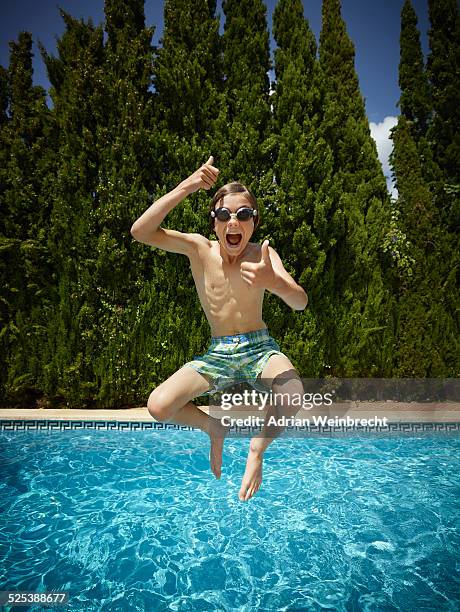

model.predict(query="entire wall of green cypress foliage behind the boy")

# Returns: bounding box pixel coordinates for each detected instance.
[0,0,460,407]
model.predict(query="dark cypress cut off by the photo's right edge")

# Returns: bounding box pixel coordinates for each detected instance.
[424,0,460,376]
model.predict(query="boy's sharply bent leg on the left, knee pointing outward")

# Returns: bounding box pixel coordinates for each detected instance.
[147,366,227,478]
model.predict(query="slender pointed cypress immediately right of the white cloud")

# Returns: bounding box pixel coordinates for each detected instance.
[386,2,458,377]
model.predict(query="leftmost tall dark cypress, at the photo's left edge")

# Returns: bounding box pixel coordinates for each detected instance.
[0,32,51,403]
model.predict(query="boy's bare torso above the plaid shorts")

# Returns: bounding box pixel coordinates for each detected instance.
[190,240,266,336]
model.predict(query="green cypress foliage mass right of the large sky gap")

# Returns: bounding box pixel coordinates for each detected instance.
[386,0,459,376]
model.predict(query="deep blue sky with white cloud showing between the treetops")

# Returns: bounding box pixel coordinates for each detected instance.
[0,0,429,189]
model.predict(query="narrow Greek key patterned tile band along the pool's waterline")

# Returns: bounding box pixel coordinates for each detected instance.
[0,419,460,437]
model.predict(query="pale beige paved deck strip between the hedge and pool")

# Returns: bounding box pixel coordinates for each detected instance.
[0,401,460,423]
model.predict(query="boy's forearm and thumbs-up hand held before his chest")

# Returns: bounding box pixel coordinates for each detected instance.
[240,240,308,310]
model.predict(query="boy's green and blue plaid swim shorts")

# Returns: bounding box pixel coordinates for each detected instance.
[185,329,285,395]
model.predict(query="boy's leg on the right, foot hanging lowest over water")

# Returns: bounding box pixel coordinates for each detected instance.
[239,355,303,501]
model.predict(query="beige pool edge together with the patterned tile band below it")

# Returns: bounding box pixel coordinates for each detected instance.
[0,401,460,437]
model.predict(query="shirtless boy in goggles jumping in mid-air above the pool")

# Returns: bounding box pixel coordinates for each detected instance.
[131,156,308,501]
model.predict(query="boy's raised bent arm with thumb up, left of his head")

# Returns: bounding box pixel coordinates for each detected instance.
[131,156,219,255]
